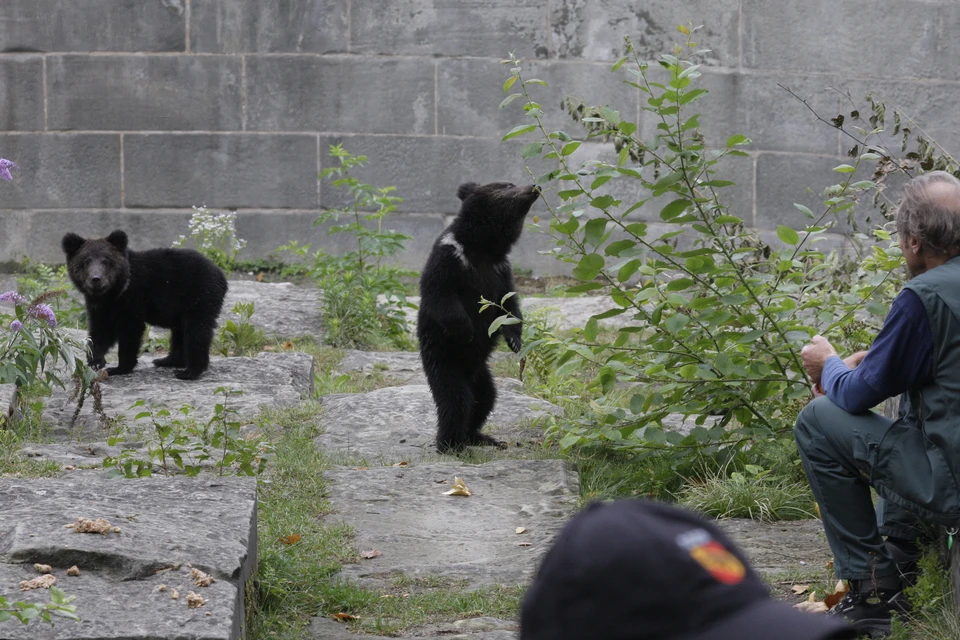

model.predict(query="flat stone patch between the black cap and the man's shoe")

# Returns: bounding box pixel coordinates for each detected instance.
[717,518,833,574]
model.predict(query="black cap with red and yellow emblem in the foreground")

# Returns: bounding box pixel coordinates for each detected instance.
[520,500,856,640]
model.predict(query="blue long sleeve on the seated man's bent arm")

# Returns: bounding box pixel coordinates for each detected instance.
[820,289,934,413]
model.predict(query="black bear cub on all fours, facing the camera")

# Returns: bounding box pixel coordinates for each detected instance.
[61,230,227,380]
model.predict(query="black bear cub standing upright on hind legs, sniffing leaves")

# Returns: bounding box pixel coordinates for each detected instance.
[417,182,540,453]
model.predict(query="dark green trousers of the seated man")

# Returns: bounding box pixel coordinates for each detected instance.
[794,396,922,580]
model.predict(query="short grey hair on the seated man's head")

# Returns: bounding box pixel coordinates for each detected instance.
[897,171,960,257]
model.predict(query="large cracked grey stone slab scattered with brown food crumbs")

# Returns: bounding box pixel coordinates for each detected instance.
[0,473,257,640]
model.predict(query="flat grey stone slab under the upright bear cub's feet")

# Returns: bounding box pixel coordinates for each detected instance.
[315,385,561,464]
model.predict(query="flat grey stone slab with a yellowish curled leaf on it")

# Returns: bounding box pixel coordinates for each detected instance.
[325,460,579,588]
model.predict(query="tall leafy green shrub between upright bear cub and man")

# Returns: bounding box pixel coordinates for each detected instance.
[501,27,901,456]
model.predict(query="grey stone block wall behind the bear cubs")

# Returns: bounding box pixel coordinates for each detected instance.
[0,0,960,273]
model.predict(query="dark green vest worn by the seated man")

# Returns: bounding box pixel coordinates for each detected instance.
[872,257,960,524]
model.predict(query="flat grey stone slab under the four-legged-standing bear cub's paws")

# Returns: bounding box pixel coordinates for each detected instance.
[44,352,313,442]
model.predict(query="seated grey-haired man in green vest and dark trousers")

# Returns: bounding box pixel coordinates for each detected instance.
[794,171,960,637]
